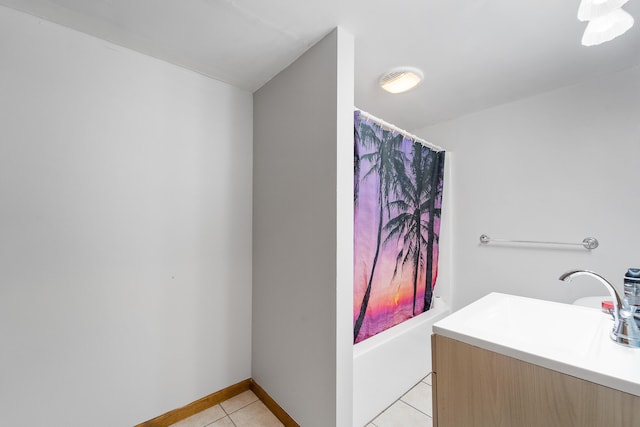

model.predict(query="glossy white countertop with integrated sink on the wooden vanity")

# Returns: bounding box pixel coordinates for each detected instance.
[433,293,640,396]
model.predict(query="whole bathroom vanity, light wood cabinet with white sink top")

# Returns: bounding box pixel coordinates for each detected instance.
[432,293,640,427]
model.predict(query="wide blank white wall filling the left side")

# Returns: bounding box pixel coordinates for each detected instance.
[0,7,252,427]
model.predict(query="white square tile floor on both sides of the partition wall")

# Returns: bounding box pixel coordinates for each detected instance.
[172,374,433,427]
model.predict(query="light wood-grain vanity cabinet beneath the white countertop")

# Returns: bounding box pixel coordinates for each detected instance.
[431,334,640,427]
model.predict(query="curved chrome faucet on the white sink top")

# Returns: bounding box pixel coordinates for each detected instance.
[560,270,640,347]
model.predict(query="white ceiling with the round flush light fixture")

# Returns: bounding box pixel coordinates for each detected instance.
[0,0,640,130]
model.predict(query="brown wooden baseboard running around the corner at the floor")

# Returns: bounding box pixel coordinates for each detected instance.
[135,378,300,427]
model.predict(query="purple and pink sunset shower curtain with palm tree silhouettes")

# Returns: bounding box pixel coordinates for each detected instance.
[353,111,445,343]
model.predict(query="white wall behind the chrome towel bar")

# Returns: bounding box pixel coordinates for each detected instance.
[416,67,640,308]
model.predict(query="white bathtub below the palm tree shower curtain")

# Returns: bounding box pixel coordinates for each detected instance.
[353,300,451,427]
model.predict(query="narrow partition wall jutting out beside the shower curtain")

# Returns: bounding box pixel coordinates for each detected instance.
[252,29,354,427]
